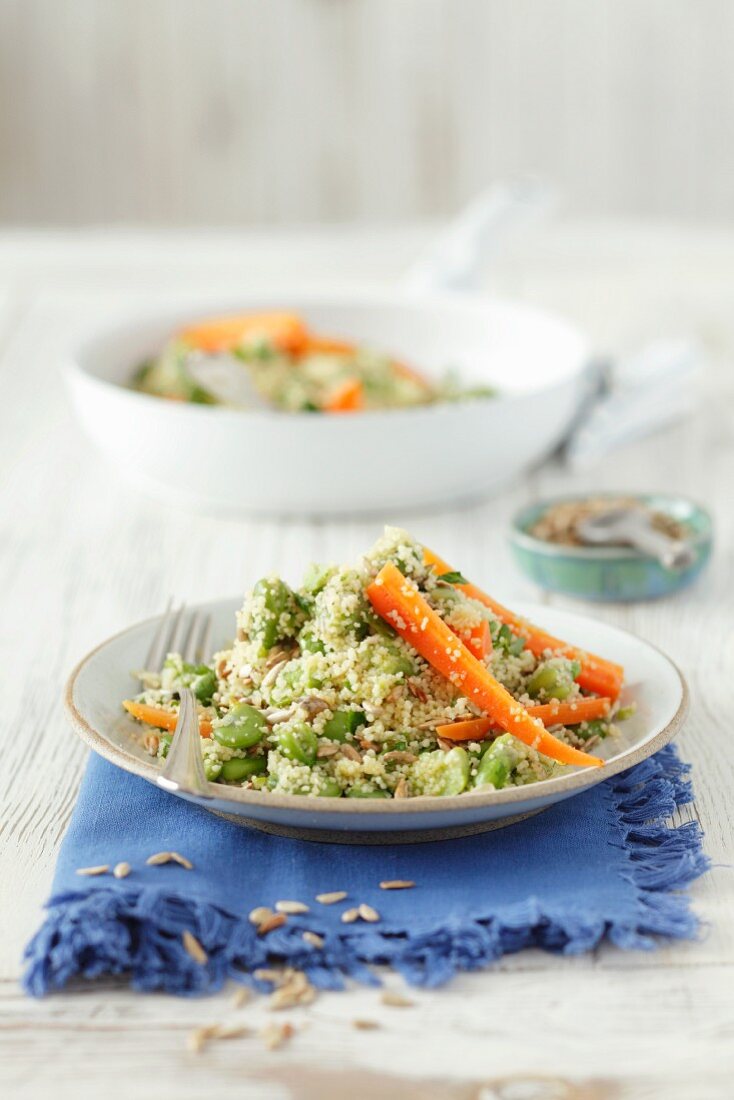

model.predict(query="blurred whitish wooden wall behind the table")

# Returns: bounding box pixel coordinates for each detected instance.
[0,0,734,224]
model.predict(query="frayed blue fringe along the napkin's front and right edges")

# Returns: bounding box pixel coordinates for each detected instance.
[23,747,709,997]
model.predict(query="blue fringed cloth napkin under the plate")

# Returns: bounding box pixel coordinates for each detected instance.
[25,747,708,996]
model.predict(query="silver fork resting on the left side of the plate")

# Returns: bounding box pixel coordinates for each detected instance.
[145,600,211,799]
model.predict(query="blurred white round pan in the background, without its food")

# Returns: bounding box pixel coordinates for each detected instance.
[67,293,587,516]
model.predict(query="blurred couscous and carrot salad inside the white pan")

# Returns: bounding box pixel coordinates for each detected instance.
[133,314,493,414]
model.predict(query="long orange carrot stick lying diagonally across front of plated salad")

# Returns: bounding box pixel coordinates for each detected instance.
[366,562,603,767]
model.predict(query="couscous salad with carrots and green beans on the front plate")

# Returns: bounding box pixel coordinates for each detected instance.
[123,528,628,799]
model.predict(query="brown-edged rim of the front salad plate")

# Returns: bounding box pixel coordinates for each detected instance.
[63,596,690,823]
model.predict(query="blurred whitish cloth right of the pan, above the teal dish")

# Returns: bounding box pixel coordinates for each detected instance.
[563,339,703,469]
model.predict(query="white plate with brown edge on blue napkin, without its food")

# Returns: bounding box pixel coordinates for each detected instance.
[65,600,687,844]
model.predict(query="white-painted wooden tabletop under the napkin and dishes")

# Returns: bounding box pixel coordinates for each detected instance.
[0,224,734,1100]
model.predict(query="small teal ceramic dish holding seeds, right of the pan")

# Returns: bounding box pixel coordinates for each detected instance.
[511,493,712,602]
